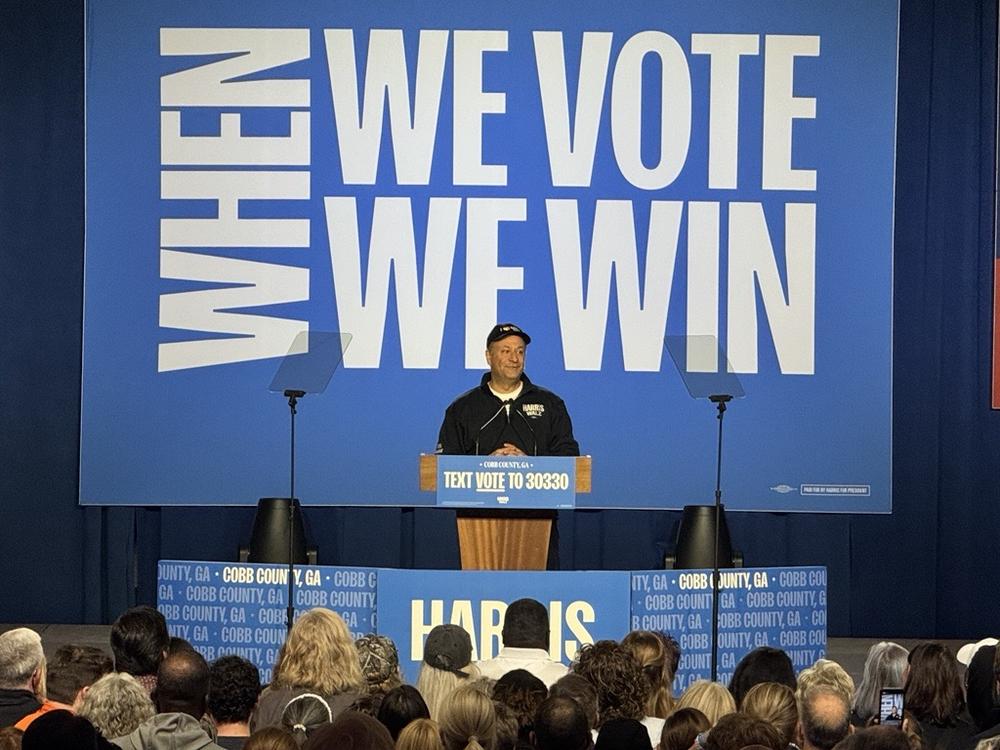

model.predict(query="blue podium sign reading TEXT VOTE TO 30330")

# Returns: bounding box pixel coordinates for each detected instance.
[437,456,576,508]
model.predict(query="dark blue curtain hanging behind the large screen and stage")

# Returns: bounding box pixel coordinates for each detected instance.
[0,0,1000,637]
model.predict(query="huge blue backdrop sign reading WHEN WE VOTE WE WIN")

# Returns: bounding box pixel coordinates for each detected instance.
[80,0,898,512]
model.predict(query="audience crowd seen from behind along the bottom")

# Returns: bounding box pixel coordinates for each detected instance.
[0,599,1000,750]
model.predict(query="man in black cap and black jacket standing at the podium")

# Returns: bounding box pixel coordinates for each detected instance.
[437,323,580,456]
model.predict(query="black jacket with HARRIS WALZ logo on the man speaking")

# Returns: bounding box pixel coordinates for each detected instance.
[437,373,580,456]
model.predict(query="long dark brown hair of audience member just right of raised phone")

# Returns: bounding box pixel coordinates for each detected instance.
[903,643,965,725]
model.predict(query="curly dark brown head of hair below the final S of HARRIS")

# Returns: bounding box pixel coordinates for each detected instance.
[573,641,649,725]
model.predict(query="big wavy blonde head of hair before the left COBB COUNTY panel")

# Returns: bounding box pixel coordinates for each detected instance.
[271,607,364,695]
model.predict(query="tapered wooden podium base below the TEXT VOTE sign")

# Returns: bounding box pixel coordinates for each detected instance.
[457,511,554,570]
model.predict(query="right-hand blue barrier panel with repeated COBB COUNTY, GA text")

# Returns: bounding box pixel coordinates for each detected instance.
[630,567,826,693]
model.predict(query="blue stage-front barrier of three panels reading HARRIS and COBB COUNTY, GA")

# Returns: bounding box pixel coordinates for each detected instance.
[158,560,826,692]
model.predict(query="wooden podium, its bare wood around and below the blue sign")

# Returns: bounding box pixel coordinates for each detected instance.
[420,453,591,570]
